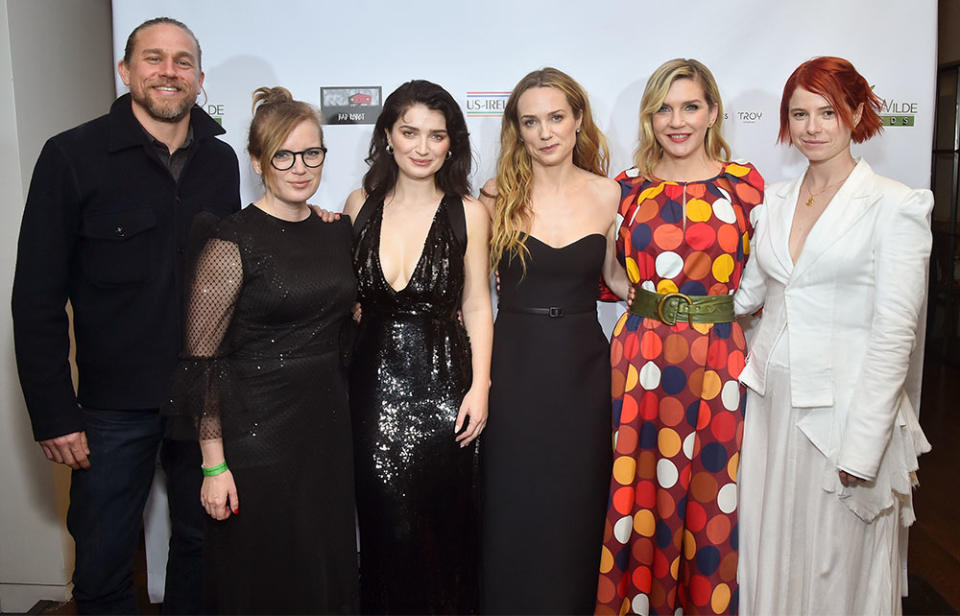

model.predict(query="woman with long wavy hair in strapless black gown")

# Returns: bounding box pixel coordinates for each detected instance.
[481,68,627,614]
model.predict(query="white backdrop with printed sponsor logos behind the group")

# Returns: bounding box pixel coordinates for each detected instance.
[113,0,937,598]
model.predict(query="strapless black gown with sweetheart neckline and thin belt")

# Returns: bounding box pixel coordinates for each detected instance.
[481,234,611,614]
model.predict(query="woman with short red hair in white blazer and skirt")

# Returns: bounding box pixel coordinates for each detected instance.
[735,57,933,614]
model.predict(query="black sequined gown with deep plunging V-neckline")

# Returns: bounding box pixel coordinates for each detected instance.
[350,197,478,614]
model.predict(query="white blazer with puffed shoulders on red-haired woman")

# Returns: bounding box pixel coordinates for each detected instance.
[734,160,933,520]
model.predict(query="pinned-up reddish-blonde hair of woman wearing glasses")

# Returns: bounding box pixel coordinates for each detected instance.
[247,86,323,188]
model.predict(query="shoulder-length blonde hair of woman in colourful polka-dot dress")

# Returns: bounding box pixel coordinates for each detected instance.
[633,58,730,178]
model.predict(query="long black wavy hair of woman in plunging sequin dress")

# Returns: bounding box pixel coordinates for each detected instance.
[363,79,472,201]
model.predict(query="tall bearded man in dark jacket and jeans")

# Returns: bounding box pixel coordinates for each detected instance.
[13,17,240,614]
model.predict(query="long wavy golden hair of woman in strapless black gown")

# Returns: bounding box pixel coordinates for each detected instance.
[490,67,610,269]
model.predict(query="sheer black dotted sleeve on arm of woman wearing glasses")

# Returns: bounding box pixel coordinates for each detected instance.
[163,238,243,440]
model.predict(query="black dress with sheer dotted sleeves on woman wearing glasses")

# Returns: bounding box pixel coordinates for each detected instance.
[164,206,358,614]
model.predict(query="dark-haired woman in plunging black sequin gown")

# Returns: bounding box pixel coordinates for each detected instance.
[345,81,493,614]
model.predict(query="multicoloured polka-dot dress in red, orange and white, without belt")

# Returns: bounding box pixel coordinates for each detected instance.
[597,163,763,614]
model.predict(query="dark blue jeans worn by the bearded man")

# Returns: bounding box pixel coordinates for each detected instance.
[67,409,204,614]
